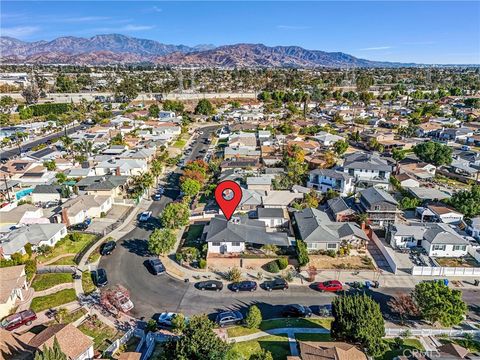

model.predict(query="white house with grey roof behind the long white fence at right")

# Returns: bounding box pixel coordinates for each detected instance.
[389,223,469,257]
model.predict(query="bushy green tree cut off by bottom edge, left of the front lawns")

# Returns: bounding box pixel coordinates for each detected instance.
[164,315,231,360]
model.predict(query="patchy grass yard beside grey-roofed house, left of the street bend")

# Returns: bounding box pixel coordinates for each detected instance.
[37,233,96,265]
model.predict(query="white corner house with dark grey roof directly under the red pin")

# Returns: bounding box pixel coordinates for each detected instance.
[202,216,292,254]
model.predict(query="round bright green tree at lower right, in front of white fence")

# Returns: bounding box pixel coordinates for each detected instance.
[412,280,467,327]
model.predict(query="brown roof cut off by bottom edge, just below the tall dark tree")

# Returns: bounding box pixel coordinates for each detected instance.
[288,341,367,360]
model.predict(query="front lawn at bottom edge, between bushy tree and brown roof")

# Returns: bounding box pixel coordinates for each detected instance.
[233,334,290,360]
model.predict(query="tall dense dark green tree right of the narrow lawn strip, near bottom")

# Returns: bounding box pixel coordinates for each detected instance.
[330,294,385,356]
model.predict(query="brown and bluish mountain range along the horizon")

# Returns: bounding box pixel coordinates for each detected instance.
[0,34,415,68]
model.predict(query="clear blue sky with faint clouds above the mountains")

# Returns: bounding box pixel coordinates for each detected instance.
[1,1,480,64]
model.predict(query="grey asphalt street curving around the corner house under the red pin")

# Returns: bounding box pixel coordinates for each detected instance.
[99,128,480,319]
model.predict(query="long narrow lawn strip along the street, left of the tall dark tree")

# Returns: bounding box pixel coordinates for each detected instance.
[227,318,332,337]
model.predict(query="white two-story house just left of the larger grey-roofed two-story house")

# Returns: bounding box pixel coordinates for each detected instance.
[307,169,355,196]
